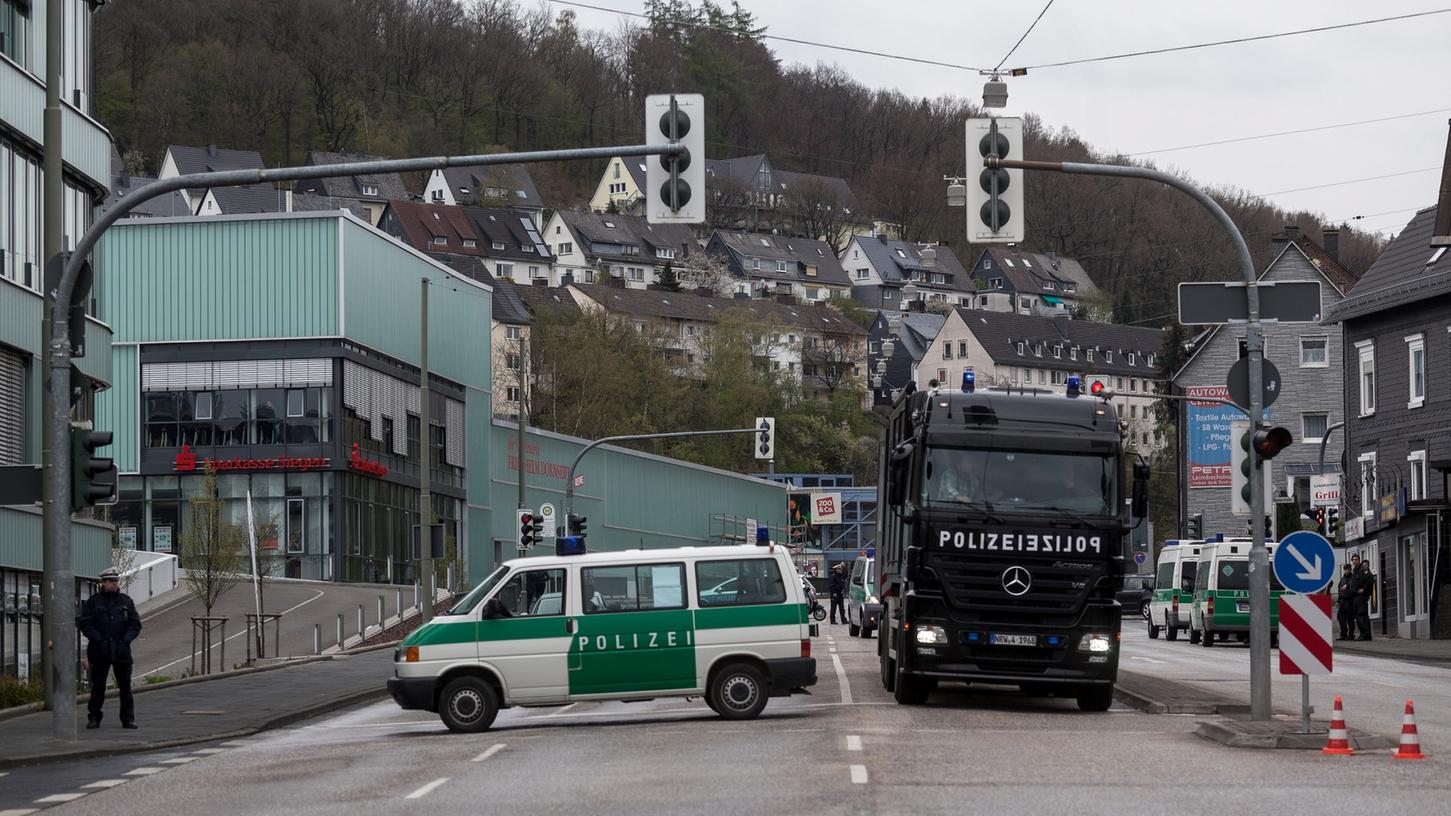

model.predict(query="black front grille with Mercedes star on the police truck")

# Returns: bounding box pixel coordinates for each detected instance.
[927,552,1107,623]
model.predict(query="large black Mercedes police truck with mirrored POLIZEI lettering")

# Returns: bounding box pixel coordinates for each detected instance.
[876,372,1148,711]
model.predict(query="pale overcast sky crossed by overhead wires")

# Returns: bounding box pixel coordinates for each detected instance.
[556,0,1451,238]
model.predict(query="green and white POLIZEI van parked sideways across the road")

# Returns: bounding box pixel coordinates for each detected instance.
[387,546,815,732]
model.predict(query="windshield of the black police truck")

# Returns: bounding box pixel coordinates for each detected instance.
[921,447,1119,517]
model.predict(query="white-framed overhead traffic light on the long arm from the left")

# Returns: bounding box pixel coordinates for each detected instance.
[644,93,705,224]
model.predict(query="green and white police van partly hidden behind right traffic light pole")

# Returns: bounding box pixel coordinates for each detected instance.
[1188,539,1284,646]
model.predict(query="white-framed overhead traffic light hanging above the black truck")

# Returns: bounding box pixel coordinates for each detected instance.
[966,116,1024,244]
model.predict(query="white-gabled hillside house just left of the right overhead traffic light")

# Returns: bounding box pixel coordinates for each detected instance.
[842,235,977,311]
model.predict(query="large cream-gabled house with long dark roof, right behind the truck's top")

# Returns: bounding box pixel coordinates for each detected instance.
[922,306,1171,452]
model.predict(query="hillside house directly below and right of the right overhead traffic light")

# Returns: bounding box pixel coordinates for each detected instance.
[969,247,1097,317]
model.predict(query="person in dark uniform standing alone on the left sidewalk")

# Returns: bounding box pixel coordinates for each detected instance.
[78,568,141,729]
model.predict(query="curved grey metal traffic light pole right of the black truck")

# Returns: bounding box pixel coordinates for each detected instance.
[985,157,1273,720]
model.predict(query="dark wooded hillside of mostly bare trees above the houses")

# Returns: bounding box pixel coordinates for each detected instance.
[94,0,1380,325]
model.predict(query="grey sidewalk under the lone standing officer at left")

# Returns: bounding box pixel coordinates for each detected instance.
[0,649,393,768]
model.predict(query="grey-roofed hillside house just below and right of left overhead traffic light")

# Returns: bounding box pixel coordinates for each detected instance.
[705,229,852,301]
